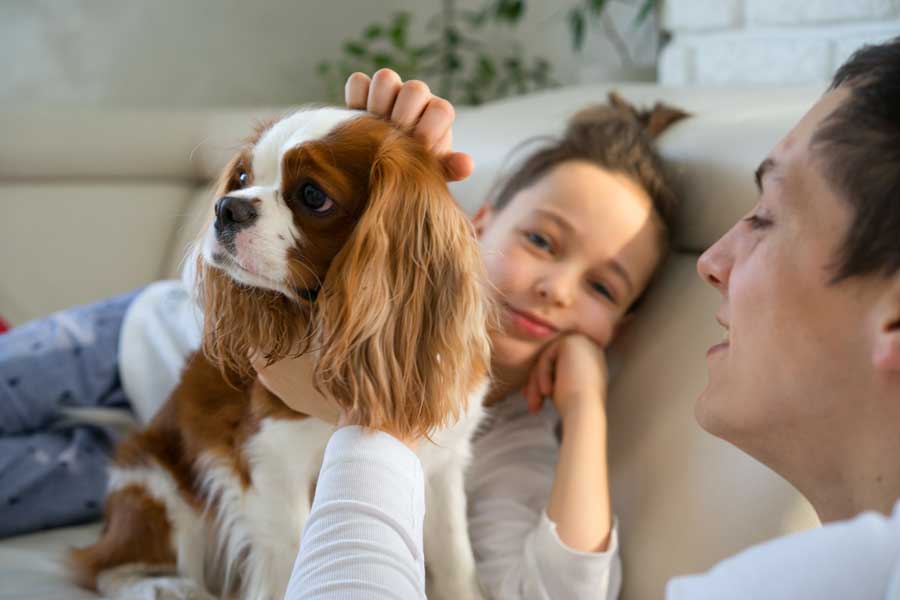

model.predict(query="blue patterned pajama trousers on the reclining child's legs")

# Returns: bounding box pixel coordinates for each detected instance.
[0,291,139,537]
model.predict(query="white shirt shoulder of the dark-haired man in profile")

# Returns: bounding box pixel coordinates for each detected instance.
[666,502,900,600]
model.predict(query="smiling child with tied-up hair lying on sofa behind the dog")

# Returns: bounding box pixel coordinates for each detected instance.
[0,71,683,598]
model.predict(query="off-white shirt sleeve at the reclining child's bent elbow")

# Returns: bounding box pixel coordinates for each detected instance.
[466,396,622,600]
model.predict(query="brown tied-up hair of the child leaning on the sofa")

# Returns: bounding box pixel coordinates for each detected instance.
[493,92,689,248]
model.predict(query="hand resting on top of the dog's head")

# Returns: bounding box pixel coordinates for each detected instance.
[344,69,472,181]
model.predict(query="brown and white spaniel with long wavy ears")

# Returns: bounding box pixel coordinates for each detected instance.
[69,107,493,600]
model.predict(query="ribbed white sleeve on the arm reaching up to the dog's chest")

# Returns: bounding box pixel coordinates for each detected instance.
[285,427,425,600]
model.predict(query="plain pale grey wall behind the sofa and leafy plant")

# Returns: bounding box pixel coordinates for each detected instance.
[0,0,656,107]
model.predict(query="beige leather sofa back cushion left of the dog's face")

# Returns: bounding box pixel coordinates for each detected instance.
[0,181,191,325]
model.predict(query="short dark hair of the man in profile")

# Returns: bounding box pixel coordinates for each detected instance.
[812,37,900,282]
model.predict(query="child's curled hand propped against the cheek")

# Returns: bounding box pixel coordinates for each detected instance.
[523,334,608,421]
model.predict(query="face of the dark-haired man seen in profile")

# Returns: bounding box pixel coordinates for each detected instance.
[696,89,882,464]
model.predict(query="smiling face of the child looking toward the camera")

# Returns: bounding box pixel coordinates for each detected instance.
[473,161,661,366]
